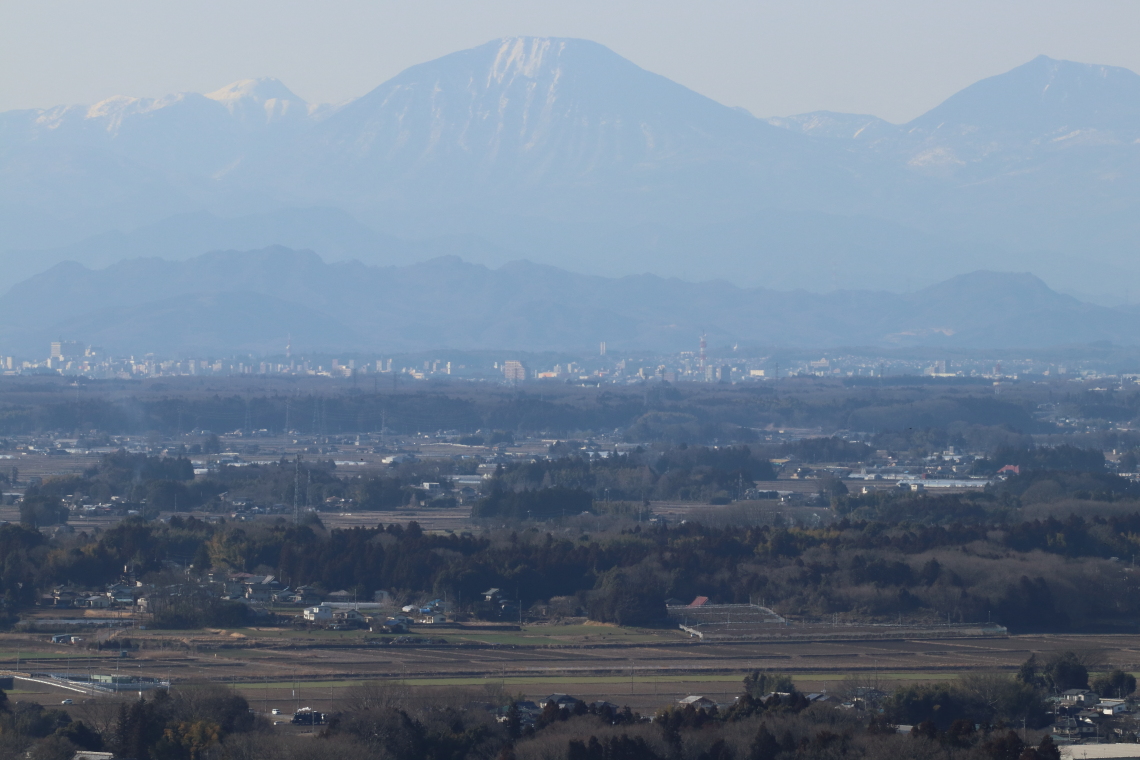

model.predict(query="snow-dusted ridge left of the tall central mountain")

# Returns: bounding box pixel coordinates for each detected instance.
[0,80,328,247]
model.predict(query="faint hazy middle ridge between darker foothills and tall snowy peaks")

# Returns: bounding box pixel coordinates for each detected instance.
[0,207,994,293]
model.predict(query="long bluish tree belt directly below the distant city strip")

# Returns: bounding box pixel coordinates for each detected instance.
[0,378,1067,448]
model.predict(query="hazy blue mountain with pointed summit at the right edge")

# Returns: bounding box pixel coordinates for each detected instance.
[768,56,1140,255]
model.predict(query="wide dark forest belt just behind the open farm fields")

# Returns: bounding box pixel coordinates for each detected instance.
[0,492,1140,630]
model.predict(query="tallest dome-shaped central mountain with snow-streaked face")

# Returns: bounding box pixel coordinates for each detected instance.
[247,38,857,224]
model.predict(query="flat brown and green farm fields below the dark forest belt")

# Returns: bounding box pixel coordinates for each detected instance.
[0,624,1140,712]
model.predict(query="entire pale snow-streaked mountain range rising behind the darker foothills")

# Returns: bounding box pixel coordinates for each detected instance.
[0,38,1140,296]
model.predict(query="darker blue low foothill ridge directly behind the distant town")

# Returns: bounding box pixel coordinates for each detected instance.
[0,247,1140,357]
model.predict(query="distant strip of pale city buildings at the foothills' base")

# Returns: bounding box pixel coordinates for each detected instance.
[0,337,1140,384]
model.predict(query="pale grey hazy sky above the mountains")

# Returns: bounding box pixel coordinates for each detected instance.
[0,0,1140,122]
